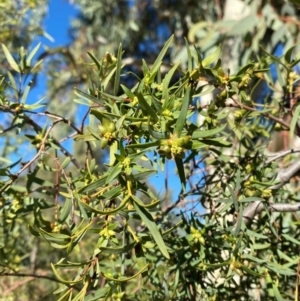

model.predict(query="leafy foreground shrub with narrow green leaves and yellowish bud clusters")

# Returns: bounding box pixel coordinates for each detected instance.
[0,25,300,301]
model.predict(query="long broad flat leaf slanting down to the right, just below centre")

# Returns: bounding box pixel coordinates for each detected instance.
[133,199,170,259]
